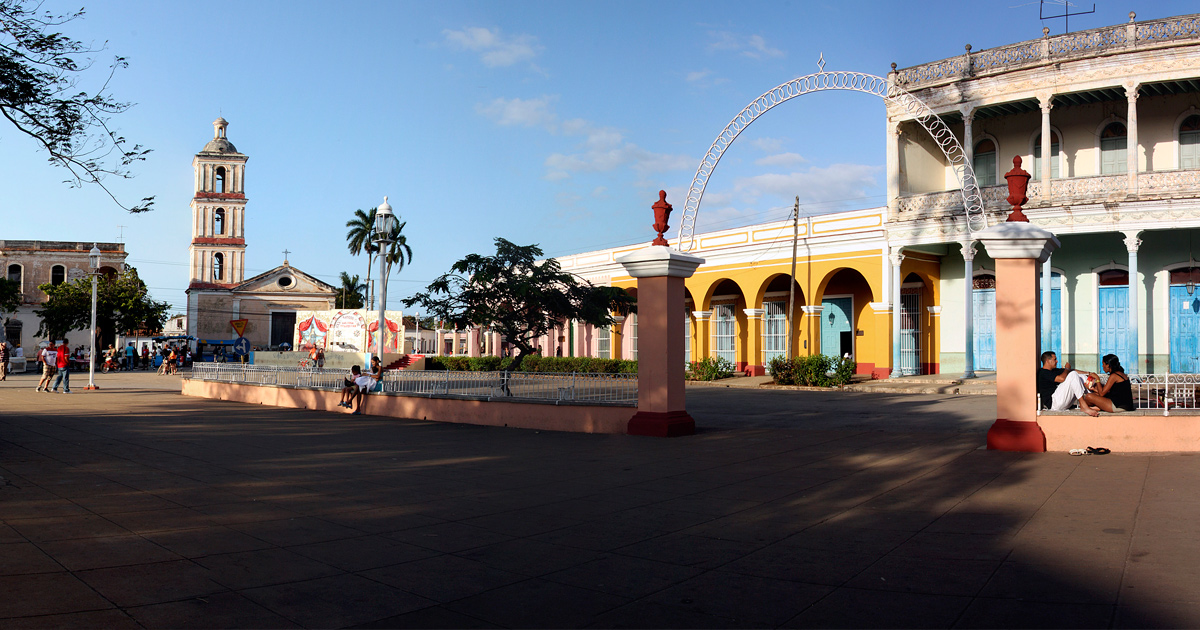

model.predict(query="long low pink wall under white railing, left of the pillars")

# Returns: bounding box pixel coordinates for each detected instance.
[182,379,637,433]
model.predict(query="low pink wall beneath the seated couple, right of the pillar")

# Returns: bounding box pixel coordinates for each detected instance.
[1038,414,1200,452]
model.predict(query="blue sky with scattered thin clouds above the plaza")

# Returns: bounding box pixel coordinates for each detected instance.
[0,0,1195,313]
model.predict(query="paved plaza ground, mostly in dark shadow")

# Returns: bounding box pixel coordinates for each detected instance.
[0,373,1200,628]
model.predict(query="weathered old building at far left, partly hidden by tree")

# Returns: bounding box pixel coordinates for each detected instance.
[0,241,126,348]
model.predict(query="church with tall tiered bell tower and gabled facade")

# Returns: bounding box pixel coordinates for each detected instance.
[187,118,336,348]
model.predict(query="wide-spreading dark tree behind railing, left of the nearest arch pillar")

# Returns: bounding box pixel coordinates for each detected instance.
[404,239,634,370]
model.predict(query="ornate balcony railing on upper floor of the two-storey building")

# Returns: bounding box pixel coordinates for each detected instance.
[893,170,1200,221]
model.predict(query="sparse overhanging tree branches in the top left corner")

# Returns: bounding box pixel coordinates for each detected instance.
[0,0,154,212]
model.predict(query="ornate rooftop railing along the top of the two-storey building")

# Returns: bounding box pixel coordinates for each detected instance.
[892,13,1200,91]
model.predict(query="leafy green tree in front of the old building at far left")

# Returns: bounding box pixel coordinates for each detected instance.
[34,266,170,338]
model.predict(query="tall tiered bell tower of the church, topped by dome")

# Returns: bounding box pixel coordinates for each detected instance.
[188,118,247,288]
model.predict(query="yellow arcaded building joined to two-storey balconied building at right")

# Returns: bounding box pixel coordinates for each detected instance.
[530,13,1200,376]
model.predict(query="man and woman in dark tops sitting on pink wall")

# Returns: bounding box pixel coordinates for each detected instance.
[1038,352,1136,418]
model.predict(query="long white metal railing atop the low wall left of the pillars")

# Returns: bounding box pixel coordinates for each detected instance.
[192,362,637,406]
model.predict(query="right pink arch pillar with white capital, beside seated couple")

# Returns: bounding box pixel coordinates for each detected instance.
[976,221,1060,452]
